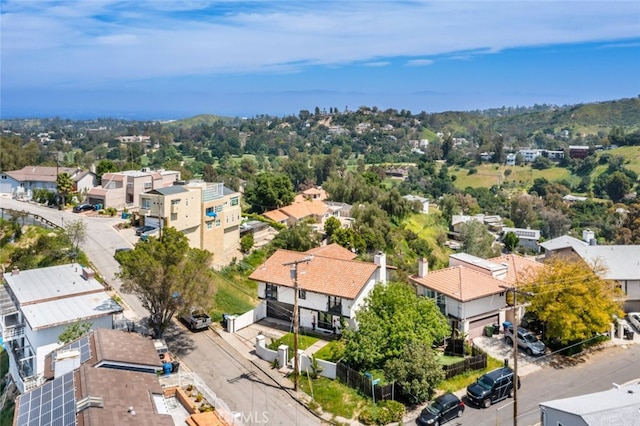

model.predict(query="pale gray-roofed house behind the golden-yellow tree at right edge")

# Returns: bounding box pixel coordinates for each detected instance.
[540,230,640,312]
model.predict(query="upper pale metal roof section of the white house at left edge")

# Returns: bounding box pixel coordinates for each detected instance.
[3,263,104,306]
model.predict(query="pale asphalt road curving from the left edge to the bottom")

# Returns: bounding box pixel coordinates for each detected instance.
[0,198,321,425]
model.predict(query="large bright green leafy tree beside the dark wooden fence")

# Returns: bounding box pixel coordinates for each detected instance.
[344,282,450,369]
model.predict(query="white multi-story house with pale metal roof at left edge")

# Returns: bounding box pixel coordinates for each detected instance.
[0,263,122,393]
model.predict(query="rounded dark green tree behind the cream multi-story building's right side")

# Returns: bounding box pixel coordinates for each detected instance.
[245,172,295,212]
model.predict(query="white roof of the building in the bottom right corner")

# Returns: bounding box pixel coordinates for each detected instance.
[540,384,640,426]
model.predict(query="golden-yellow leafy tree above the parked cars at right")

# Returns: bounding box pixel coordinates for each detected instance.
[522,258,623,344]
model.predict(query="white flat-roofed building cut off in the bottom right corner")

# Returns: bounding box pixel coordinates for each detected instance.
[540,381,640,426]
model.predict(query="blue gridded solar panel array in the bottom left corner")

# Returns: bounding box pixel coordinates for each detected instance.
[16,371,76,426]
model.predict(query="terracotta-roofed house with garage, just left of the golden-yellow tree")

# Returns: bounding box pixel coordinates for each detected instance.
[409,253,543,339]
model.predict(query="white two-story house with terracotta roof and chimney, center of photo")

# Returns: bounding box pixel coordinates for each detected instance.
[249,244,388,332]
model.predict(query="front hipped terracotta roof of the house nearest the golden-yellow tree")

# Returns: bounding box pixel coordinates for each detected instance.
[409,265,507,302]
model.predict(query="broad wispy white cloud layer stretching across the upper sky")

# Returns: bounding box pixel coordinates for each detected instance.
[0,0,640,86]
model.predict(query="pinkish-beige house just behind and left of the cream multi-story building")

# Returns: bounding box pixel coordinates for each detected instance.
[87,169,180,209]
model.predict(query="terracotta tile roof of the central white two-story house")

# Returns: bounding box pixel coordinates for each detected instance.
[249,249,378,299]
